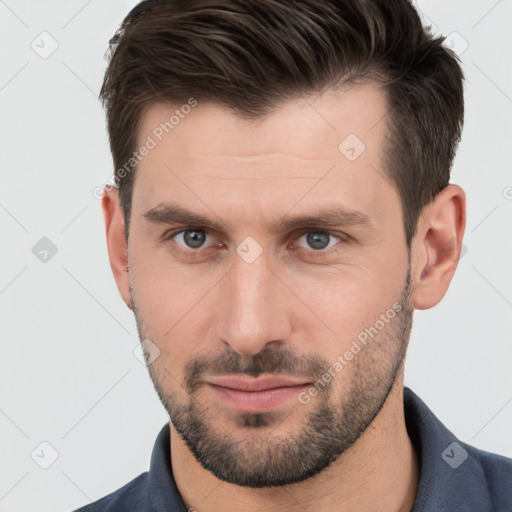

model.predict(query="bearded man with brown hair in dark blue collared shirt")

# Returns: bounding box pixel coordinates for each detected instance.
[74,0,512,512]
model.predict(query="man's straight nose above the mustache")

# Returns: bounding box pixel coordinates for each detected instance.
[216,249,291,354]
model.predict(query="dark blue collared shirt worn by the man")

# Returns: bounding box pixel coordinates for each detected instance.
[71,388,512,512]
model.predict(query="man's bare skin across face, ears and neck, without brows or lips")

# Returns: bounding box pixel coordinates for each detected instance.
[103,84,465,512]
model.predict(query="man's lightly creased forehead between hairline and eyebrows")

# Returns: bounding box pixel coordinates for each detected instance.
[133,84,396,224]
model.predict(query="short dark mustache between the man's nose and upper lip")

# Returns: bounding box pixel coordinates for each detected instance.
[184,347,329,393]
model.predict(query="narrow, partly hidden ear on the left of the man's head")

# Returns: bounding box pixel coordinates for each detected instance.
[101,187,132,309]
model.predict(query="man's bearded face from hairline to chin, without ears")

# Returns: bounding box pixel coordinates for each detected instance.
[128,85,412,487]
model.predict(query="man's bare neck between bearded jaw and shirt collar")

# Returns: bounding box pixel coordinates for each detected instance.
[170,374,419,512]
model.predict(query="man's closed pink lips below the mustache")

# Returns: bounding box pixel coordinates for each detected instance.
[206,376,311,413]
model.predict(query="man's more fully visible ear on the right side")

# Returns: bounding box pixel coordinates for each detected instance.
[411,185,466,309]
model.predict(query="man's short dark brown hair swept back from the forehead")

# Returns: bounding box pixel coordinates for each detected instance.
[100,0,464,244]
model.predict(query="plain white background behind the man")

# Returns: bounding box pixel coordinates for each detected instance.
[0,0,512,512]
